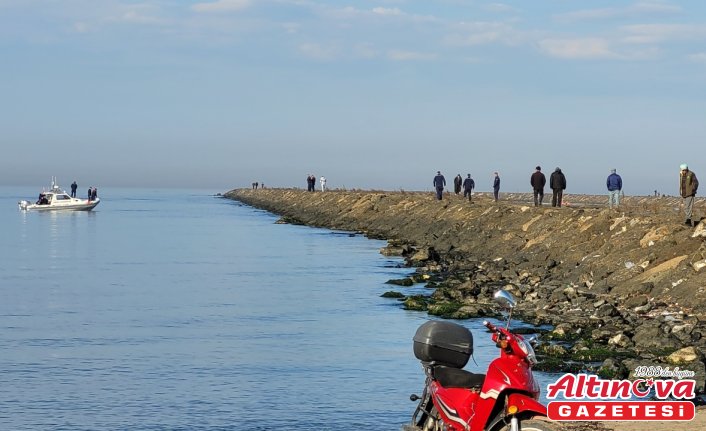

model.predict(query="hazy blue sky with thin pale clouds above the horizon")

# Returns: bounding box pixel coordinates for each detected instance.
[0,0,706,195]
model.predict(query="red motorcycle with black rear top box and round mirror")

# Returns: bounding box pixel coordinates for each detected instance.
[404,290,556,431]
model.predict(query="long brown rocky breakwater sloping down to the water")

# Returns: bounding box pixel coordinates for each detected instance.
[225,189,706,392]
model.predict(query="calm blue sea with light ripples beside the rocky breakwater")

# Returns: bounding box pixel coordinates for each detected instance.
[0,187,556,431]
